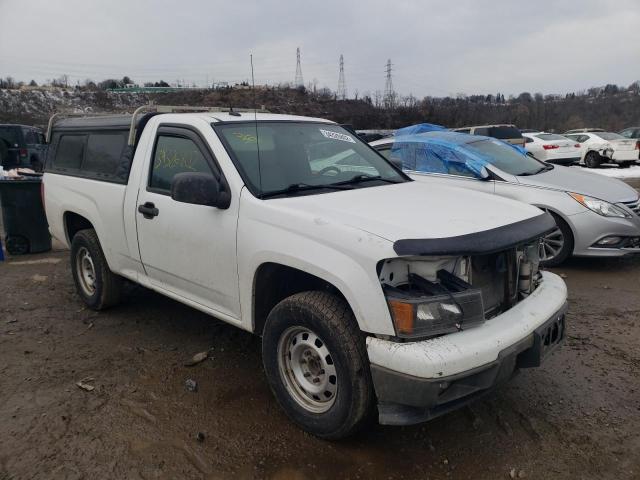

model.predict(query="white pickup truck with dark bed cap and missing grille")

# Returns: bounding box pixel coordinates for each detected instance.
[44,107,567,439]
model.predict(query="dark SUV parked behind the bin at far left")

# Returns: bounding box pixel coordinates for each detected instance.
[0,124,47,172]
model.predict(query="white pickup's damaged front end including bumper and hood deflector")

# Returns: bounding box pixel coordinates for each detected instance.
[367,213,567,425]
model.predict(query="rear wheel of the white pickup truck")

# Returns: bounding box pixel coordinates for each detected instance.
[71,229,123,310]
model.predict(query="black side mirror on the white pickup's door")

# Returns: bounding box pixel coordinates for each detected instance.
[171,172,231,209]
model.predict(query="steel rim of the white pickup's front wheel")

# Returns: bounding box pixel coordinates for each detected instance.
[278,327,338,413]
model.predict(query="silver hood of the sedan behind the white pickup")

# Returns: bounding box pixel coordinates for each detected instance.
[517,165,638,203]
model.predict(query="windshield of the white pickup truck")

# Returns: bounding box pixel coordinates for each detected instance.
[213,121,406,198]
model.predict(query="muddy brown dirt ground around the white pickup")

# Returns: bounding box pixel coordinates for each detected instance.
[0,182,640,480]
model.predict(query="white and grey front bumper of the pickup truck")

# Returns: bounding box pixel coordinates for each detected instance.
[367,272,567,425]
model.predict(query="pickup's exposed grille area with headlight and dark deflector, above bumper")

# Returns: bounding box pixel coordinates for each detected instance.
[378,213,555,341]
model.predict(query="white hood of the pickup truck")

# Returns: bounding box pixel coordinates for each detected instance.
[268,181,542,242]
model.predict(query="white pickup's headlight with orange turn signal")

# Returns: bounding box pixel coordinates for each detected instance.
[387,289,484,338]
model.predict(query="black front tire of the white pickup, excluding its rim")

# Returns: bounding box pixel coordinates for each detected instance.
[262,291,375,440]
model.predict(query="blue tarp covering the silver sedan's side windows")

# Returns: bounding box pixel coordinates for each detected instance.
[391,127,495,178]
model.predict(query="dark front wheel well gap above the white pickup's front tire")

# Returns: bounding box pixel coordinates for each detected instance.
[253,263,346,335]
